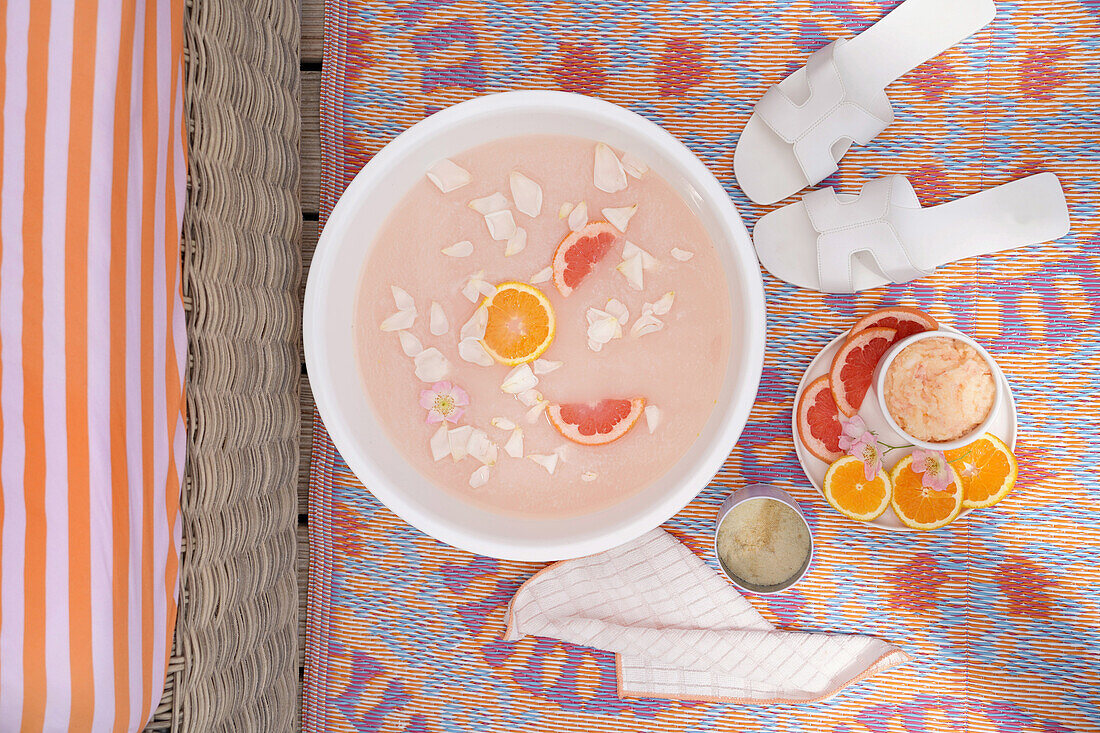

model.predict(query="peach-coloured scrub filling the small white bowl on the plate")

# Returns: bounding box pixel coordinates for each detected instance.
[883,337,997,442]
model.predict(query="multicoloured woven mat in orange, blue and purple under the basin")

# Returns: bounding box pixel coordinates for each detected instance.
[304,0,1100,733]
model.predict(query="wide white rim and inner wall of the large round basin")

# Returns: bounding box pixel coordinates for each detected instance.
[303,91,766,560]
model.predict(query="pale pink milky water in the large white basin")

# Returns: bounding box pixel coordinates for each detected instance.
[354,135,730,516]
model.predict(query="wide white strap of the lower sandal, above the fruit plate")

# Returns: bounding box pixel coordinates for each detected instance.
[802,176,931,293]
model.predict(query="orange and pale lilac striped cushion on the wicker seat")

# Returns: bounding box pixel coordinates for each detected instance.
[0,0,186,731]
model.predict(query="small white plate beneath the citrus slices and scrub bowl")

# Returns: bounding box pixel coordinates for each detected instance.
[791,326,1016,532]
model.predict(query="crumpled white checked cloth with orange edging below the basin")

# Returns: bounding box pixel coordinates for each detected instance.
[504,529,910,703]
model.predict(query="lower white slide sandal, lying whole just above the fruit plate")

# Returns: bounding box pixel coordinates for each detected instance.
[752,173,1069,293]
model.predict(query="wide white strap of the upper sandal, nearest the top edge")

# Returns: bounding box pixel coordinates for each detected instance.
[755,39,893,184]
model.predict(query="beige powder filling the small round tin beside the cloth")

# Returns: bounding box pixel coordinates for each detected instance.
[718,497,811,587]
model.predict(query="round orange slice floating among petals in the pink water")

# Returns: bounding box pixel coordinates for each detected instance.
[481,283,556,367]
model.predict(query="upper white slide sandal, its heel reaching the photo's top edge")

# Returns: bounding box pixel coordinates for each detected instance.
[734,0,996,205]
